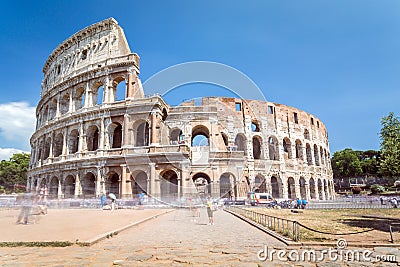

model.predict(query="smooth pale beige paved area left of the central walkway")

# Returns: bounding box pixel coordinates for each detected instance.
[0,209,168,243]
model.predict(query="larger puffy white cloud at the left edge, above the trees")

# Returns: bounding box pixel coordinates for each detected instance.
[0,102,36,149]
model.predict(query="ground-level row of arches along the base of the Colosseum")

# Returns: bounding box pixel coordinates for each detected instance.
[28,169,334,200]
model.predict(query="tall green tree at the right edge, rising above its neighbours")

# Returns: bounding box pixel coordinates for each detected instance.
[379,112,400,178]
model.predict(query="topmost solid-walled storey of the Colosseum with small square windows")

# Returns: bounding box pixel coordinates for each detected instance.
[41,18,139,96]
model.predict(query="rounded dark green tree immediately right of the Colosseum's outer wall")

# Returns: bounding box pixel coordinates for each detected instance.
[331,148,363,178]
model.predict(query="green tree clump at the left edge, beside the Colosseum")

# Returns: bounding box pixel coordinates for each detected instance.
[0,153,30,193]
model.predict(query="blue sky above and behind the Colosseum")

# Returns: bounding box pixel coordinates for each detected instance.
[0,0,400,159]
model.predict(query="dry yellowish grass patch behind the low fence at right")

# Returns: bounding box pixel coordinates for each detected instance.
[244,208,400,243]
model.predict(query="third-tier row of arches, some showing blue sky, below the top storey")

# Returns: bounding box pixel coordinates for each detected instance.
[37,76,126,126]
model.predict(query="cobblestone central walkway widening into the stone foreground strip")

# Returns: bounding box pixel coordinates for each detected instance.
[0,209,400,266]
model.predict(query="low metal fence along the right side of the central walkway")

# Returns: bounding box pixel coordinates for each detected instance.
[226,206,300,241]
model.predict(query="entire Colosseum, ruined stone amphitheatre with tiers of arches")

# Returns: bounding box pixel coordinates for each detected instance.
[27,18,334,201]
